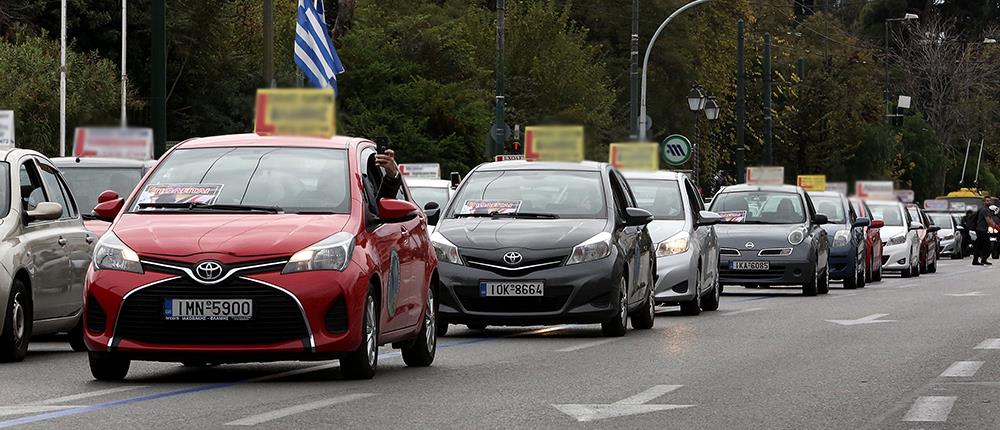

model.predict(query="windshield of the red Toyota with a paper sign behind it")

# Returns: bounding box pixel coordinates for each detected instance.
[130,147,351,213]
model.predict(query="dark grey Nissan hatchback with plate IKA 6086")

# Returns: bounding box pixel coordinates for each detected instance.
[710,184,830,296]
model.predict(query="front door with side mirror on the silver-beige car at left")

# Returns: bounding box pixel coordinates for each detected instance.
[18,156,72,320]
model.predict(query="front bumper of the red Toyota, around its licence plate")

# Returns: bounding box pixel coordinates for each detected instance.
[84,262,368,362]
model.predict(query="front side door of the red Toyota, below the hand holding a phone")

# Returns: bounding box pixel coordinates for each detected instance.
[358,146,406,333]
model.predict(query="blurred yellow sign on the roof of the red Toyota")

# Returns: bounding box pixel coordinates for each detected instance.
[254,88,337,137]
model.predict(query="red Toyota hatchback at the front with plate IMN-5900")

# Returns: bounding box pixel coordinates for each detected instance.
[84,134,438,380]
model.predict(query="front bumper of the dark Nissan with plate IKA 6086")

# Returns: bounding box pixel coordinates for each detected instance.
[719,256,816,285]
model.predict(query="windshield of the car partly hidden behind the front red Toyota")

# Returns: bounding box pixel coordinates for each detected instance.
[59,166,143,207]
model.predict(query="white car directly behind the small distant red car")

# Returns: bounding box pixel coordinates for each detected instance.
[867,200,924,278]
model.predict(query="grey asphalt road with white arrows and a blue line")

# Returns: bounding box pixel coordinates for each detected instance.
[0,259,1000,429]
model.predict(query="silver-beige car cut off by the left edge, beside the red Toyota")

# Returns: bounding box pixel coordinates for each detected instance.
[0,149,96,361]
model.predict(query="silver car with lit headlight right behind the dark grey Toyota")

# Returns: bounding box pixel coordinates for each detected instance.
[624,171,721,315]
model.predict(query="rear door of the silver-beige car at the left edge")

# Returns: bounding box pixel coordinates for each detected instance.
[35,159,94,315]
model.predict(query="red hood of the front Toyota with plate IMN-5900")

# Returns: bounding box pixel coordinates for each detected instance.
[114,214,350,257]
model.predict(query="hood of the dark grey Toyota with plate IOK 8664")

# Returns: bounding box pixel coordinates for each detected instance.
[436,218,608,250]
